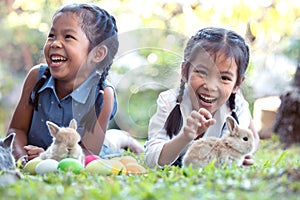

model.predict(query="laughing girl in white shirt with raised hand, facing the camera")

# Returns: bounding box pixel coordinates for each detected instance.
[145,28,259,167]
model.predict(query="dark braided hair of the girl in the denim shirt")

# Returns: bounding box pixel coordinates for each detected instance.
[30,4,119,131]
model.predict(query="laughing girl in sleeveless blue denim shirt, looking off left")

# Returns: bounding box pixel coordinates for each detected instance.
[8,4,142,160]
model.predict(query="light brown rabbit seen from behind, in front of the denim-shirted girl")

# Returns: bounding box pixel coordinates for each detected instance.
[39,119,84,164]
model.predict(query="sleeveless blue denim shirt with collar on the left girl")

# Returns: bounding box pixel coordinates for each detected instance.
[28,65,117,149]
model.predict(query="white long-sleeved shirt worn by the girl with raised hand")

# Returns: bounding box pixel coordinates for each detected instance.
[145,89,251,167]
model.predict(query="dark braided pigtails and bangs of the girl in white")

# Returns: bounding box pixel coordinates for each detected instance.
[165,27,249,138]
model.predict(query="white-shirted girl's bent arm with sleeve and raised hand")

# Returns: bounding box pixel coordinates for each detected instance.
[145,90,215,167]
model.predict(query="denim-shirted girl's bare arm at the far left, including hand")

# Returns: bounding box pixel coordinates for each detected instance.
[7,67,39,160]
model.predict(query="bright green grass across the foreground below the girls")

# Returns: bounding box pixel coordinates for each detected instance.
[0,137,300,200]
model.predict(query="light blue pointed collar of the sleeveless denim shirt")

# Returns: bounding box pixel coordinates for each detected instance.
[38,72,101,104]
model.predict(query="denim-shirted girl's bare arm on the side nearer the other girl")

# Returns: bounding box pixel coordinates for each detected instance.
[82,87,115,155]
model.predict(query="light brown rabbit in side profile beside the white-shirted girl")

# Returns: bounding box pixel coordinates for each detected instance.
[182,116,254,168]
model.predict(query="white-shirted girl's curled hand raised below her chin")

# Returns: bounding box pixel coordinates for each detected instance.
[183,108,216,140]
